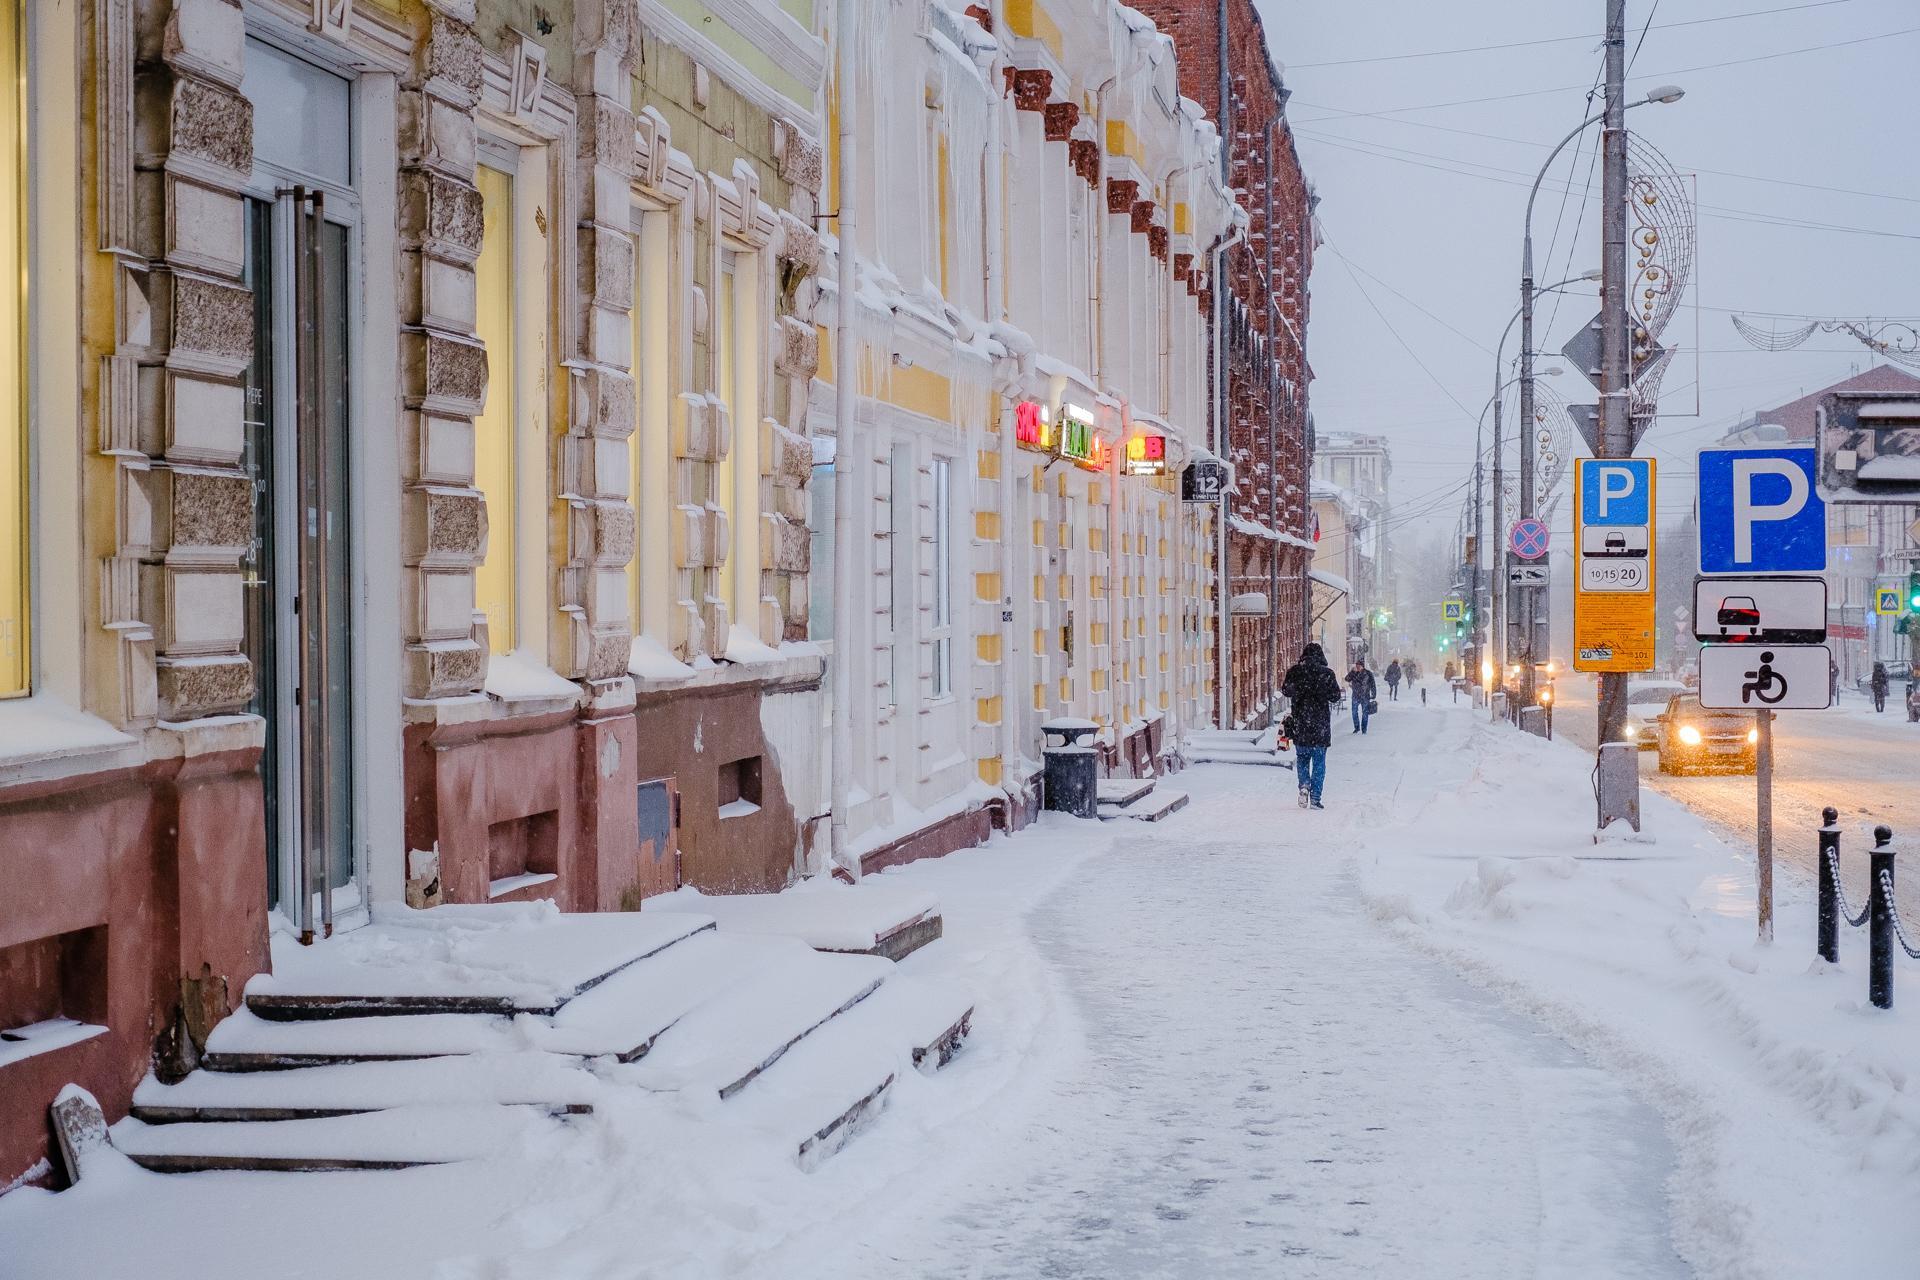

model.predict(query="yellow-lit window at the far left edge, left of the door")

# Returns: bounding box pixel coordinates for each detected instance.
[0,0,29,697]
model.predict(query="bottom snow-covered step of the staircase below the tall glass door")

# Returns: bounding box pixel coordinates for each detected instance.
[111,1103,564,1173]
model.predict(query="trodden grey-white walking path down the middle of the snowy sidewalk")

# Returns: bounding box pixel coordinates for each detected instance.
[787,704,1686,1278]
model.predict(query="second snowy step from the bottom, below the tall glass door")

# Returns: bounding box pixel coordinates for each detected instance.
[132,1052,601,1125]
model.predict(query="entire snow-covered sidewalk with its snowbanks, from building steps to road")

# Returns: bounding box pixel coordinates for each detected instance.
[0,700,1920,1280]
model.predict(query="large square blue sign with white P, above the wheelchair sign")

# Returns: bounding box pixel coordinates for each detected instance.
[1697,447,1826,574]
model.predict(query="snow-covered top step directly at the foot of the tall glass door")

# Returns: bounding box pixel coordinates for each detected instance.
[246,902,712,1019]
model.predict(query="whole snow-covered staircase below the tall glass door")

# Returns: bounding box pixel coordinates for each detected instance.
[111,887,973,1173]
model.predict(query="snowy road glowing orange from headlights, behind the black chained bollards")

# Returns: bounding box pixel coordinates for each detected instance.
[1553,676,1920,912]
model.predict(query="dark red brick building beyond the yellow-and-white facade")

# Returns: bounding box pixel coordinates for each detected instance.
[1135,0,1315,723]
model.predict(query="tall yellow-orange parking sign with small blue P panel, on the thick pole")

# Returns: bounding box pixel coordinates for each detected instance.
[1572,459,1659,672]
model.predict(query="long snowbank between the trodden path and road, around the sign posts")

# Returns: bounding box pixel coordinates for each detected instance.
[1356,716,1920,1280]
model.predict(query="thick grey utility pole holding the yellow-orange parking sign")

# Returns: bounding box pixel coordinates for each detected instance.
[1599,0,1640,756]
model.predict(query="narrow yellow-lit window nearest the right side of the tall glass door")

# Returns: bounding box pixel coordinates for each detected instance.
[474,163,518,652]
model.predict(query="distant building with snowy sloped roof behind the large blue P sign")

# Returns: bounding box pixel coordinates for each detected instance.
[1718,365,1920,685]
